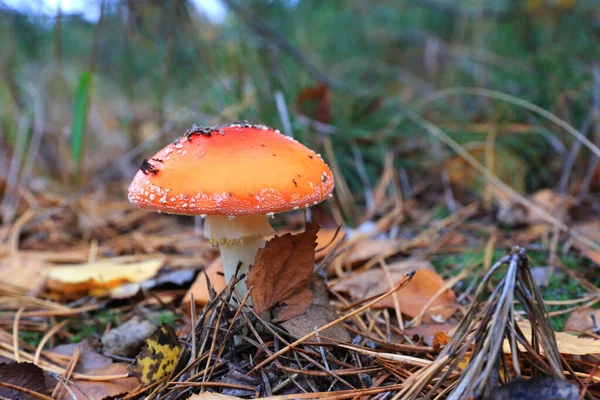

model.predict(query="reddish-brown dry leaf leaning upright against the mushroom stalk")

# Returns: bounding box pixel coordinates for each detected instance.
[246,222,319,322]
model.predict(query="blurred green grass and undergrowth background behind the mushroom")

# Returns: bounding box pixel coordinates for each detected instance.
[0,0,600,223]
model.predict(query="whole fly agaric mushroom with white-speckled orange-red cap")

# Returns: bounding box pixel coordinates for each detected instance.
[128,121,333,295]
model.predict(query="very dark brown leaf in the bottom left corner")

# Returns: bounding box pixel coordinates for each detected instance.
[0,362,47,400]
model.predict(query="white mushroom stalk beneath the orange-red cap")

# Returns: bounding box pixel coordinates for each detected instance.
[204,215,273,304]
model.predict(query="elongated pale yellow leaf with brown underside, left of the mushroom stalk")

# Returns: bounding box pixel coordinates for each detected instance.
[46,257,163,298]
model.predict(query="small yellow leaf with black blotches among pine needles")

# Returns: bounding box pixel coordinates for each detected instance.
[127,324,181,385]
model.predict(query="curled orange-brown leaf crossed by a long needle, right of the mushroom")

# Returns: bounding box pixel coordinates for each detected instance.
[331,261,456,323]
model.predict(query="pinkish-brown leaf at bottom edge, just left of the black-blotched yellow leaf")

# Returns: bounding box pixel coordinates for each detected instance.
[60,363,139,400]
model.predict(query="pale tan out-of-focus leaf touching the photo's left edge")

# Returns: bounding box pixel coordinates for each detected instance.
[0,254,50,296]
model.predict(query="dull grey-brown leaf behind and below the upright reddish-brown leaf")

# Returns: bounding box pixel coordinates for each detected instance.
[273,275,350,342]
